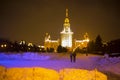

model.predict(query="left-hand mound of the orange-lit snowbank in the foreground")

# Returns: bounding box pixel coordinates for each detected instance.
[0,68,59,80]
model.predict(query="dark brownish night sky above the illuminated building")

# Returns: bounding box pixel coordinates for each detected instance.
[0,0,120,45]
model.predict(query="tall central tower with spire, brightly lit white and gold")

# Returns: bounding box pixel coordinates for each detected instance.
[60,9,73,48]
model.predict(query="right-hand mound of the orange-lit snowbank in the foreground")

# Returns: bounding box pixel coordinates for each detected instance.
[60,68,107,80]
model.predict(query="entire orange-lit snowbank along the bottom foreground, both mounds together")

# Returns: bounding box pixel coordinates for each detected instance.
[0,67,107,80]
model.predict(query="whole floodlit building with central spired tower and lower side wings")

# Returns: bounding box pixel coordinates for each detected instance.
[44,9,89,51]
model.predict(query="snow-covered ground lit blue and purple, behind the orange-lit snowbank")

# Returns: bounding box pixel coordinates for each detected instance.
[0,52,120,80]
